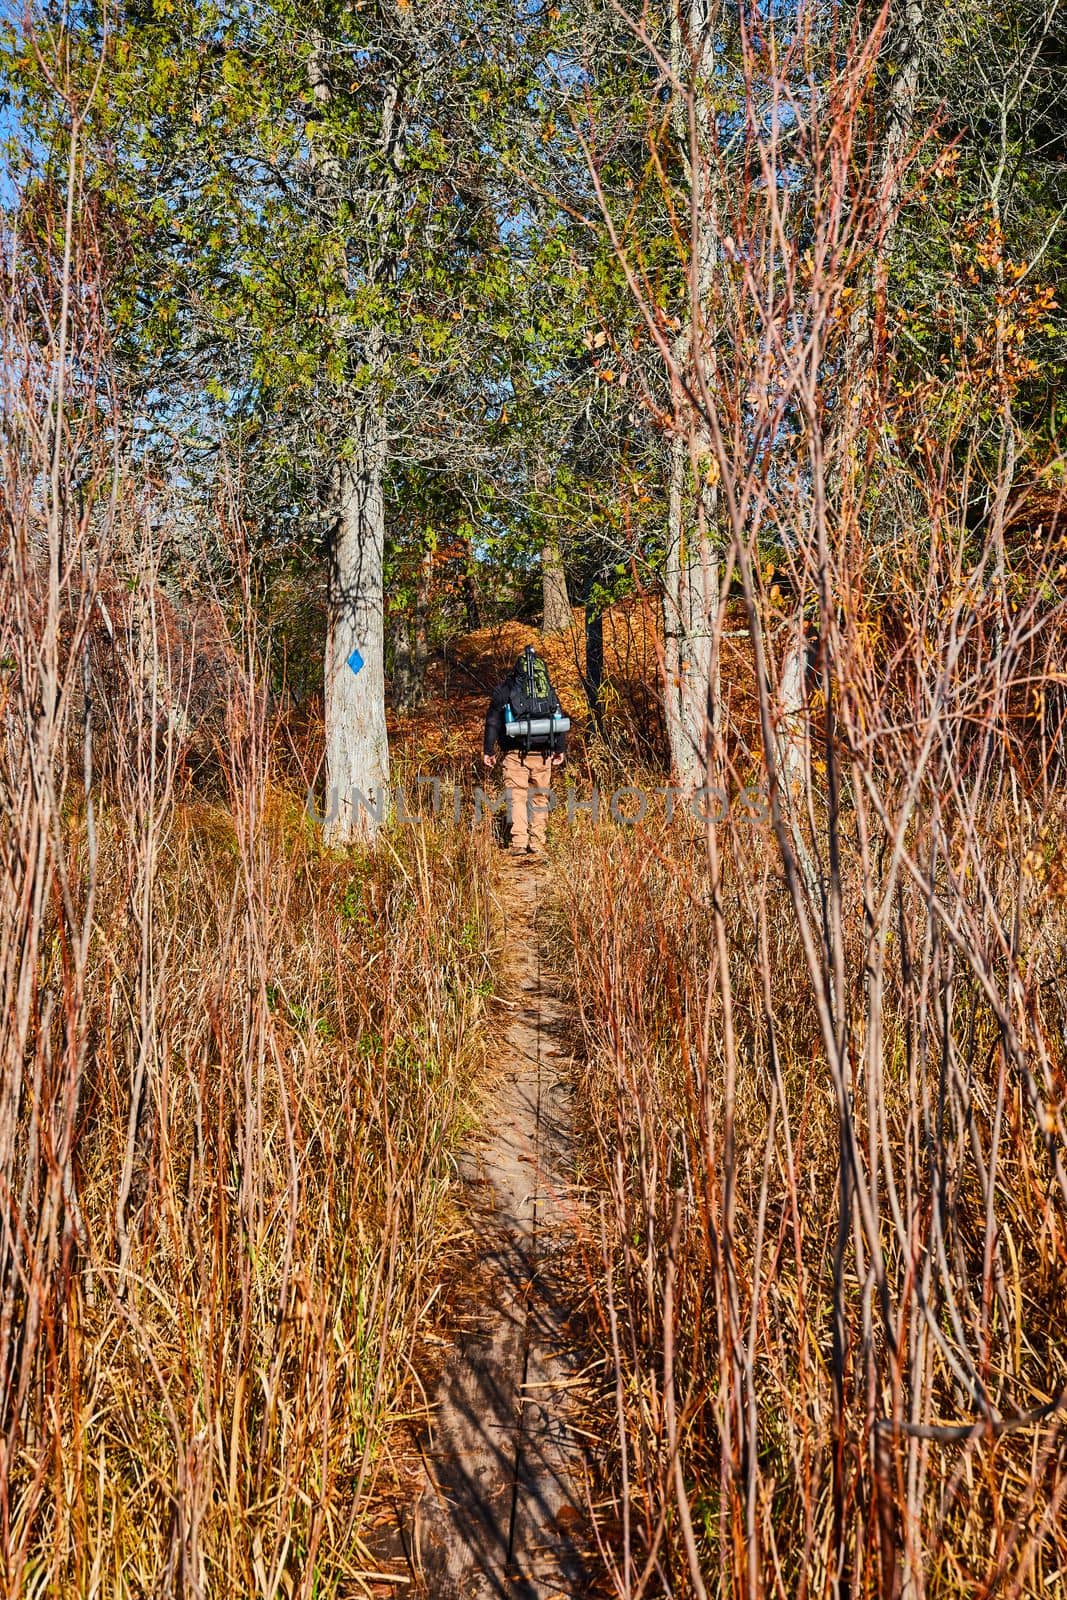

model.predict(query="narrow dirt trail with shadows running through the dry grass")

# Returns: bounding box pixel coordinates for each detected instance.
[379,861,589,1600]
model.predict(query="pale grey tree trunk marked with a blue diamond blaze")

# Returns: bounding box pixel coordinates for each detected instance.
[325,410,389,845]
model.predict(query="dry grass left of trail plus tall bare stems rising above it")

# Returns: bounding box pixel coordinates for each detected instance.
[0,147,494,1597]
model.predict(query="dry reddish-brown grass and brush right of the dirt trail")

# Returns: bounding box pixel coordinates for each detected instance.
[555,790,1067,1597]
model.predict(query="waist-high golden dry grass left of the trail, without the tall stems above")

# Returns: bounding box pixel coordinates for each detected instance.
[5,748,493,1595]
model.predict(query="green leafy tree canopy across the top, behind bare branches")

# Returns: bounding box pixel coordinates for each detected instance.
[3,0,1067,646]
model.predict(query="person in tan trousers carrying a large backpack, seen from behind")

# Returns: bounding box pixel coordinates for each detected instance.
[482,645,571,856]
